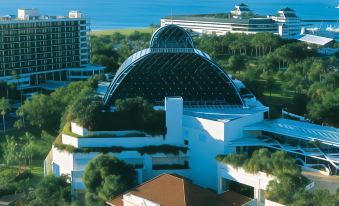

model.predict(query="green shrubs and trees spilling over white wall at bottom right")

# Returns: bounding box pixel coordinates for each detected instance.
[216,149,339,206]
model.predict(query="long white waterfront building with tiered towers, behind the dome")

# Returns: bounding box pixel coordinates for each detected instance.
[160,4,301,38]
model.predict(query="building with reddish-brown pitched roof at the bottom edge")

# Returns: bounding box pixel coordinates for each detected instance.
[107,174,253,206]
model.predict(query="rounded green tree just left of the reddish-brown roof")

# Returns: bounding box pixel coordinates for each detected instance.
[83,154,136,205]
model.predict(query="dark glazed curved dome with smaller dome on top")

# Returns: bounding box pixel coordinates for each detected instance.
[104,25,244,106]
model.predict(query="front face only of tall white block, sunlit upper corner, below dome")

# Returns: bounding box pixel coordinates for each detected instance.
[183,115,224,189]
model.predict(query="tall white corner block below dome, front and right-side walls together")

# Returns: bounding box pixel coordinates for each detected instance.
[183,109,264,190]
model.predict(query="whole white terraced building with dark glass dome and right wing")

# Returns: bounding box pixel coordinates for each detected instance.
[45,25,339,205]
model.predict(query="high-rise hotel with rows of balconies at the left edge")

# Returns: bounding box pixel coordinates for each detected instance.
[0,9,104,89]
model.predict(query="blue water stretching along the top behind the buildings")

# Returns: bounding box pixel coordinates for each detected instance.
[0,0,339,29]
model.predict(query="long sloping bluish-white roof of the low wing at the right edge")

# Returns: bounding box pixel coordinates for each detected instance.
[244,119,339,146]
